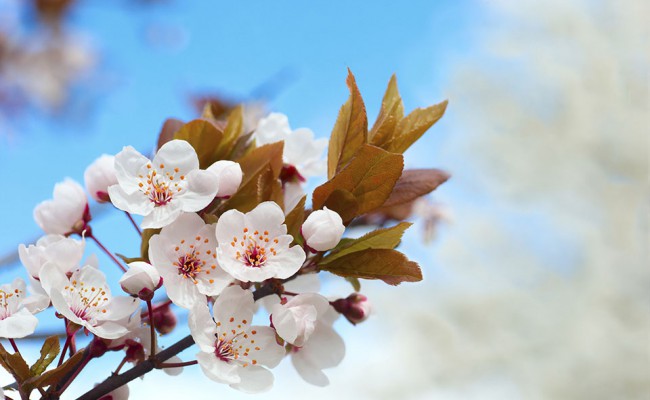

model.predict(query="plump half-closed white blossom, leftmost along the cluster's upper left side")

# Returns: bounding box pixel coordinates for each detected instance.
[34,178,90,235]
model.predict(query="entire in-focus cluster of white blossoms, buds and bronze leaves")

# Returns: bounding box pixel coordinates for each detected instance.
[0,70,447,398]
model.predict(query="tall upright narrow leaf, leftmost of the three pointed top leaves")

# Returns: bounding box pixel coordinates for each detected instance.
[327,69,368,179]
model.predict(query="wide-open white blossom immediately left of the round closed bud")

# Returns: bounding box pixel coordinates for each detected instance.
[217,201,306,282]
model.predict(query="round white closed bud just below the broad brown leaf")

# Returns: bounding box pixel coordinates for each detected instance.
[302,207,345,251]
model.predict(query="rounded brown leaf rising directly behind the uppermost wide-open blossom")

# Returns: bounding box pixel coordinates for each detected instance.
[174,119,223,169]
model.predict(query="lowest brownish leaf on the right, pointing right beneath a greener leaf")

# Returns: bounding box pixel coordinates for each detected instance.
[320,249,422,285]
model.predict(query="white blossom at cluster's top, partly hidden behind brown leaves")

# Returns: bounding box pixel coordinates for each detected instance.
[255,113,327,180]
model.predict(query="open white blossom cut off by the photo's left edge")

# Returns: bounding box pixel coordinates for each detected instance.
[0,278,38,339]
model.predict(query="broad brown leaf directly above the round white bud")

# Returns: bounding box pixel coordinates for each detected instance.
[312,144,404,224]
